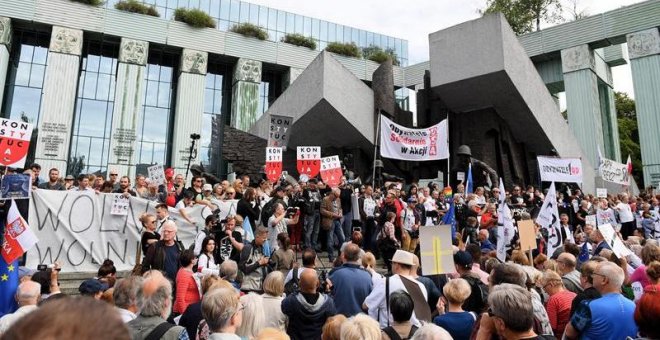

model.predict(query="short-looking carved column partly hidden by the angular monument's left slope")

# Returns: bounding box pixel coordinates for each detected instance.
[231,58,261,132]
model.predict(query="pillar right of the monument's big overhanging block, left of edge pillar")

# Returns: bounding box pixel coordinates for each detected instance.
[561,44,603,164]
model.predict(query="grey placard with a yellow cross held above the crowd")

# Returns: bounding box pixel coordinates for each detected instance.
[419,224,456,275]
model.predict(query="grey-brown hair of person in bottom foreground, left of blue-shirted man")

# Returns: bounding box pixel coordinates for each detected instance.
[488,283,534,333]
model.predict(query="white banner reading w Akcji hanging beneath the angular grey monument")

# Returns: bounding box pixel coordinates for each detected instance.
[380,116,449,161]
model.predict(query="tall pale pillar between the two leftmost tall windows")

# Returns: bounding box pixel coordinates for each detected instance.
[35,26,83,174]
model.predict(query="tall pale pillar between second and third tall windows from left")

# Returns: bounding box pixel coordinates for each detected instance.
[108,38,149,178]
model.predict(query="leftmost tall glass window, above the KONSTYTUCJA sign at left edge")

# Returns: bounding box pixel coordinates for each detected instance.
[2,29,50,164]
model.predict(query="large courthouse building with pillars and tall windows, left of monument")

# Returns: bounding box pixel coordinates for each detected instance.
[0,0,408,176]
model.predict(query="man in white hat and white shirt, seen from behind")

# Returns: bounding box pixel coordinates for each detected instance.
[362,250,428,328]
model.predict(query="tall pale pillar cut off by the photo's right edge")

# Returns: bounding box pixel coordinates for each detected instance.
[627,28,660,186]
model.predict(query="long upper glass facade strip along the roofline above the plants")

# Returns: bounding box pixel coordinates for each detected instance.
[106,0,408,66]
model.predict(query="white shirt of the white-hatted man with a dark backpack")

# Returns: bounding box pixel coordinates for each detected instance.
[364,274,428,328]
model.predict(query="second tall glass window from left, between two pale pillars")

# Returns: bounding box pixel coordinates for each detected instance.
[67,41,119,176]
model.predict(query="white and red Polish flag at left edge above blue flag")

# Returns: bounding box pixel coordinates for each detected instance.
[2,200,39,263]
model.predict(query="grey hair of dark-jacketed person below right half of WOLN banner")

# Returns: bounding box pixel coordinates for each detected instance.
[137,274,172,316]
